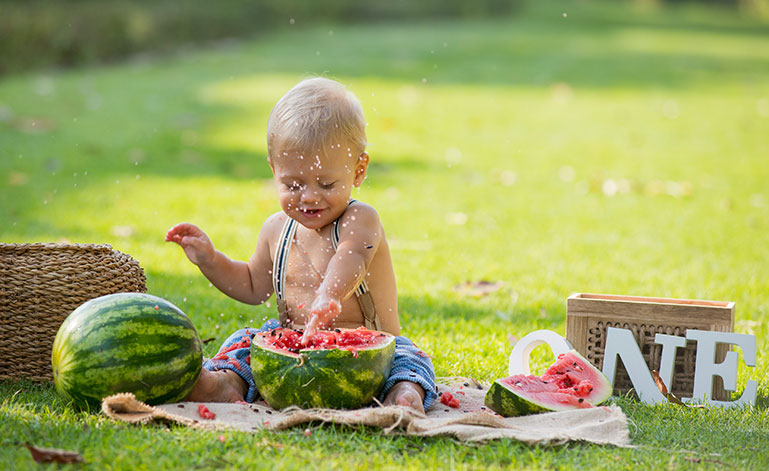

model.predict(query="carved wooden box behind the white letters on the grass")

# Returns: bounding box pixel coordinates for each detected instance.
[566,293,734,401]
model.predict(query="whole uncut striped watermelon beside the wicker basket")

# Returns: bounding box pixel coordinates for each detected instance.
[51,293,203,407]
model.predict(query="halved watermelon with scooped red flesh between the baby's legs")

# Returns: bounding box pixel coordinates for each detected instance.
[251,327,395,409]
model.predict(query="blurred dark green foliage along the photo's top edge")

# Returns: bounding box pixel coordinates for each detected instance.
[0,0,769,75]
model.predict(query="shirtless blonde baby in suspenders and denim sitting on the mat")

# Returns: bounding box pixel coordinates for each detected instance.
[165,77,437,412]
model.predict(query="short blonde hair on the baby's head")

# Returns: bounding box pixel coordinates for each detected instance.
[267,77,366,160]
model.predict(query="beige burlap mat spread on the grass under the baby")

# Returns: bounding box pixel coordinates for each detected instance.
[102,378,630,446]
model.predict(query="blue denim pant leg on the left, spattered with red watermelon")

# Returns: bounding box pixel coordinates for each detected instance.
[203,319,280,402]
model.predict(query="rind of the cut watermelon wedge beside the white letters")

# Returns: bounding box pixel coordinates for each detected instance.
[483,350,612,417]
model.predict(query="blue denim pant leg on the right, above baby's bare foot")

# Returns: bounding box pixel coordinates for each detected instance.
[379,336,438,410]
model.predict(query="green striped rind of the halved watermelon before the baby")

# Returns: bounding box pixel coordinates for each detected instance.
[251,329,395,409]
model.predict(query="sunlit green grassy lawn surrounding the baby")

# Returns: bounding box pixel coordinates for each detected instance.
[0,1,769,470]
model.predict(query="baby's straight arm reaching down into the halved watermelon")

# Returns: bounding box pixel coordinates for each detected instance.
[302,203,383,343]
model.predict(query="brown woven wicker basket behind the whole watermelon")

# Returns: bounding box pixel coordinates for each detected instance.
[0,243,147,381]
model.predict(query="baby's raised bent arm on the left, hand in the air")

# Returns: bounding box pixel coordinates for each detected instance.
[165,220,273,304]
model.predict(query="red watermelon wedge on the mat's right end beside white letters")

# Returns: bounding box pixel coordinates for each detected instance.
[484,350,612,417]
